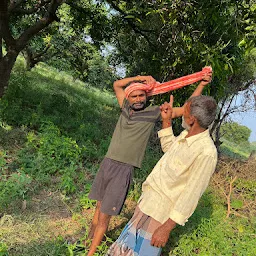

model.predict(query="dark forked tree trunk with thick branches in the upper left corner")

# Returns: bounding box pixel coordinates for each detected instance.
[0,0,64,98]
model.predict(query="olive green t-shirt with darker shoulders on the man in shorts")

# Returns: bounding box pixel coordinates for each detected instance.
[106,99,160,168]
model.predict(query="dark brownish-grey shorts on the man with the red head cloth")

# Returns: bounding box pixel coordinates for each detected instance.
[89,158,134,215]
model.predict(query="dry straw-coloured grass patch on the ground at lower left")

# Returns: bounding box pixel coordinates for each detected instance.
[0,190,84,248]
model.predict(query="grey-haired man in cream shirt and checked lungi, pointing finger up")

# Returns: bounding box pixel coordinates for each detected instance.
[107,95,217,256]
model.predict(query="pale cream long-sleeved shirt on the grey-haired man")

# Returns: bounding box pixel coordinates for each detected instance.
[139,127,217,225]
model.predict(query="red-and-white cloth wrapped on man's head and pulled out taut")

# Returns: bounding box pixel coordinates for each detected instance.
[124,66,212,98]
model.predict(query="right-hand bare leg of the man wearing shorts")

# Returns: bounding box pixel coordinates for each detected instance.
[87,212,111,256]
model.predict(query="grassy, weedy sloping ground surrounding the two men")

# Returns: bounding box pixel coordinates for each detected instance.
[0,60,256,256]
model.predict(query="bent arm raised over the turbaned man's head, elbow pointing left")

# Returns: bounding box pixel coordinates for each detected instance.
[113,76,156,107]
